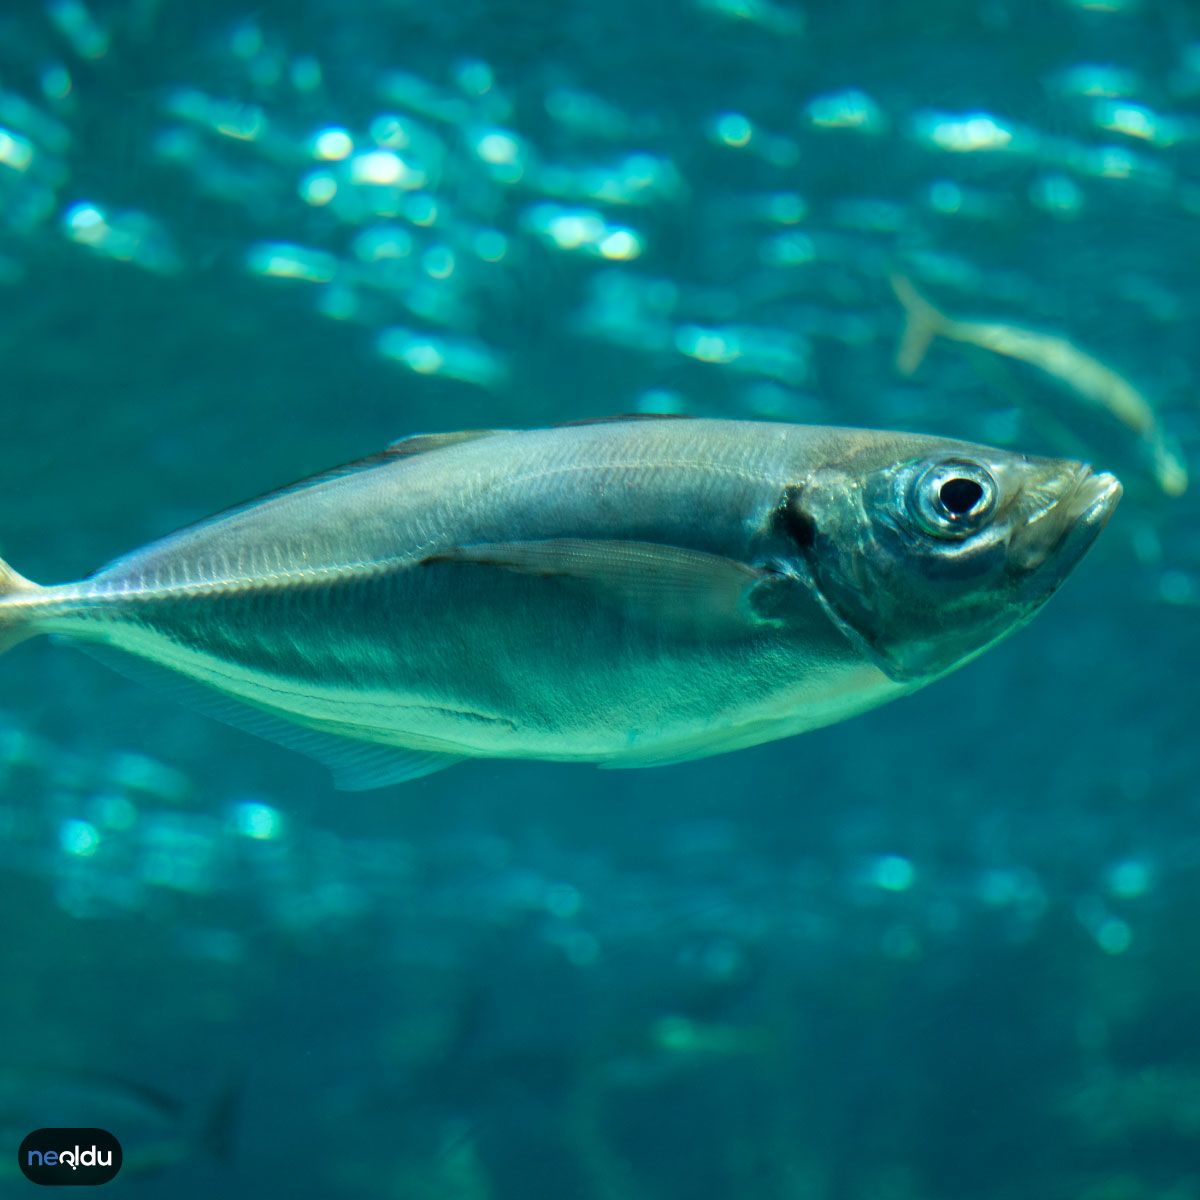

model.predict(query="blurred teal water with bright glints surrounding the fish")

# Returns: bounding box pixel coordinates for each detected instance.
[0,0,1200,1200]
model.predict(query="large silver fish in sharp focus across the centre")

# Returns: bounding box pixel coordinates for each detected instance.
[0,414,1121,790]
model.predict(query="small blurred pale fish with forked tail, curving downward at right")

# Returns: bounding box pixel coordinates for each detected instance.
[888,274,1188,497]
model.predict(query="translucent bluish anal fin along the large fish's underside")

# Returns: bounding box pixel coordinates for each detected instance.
[76,642,462,792]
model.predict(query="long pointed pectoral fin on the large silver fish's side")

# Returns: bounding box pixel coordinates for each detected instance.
[424,538,764,634]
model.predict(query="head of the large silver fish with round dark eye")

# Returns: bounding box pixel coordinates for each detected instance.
[781,444,1121,684]
